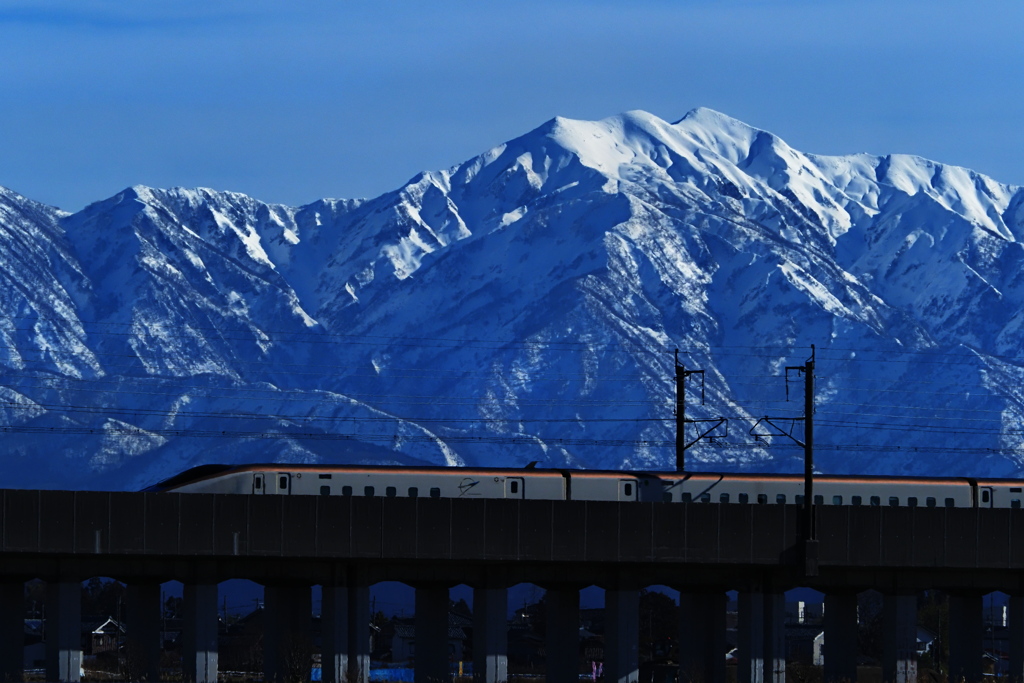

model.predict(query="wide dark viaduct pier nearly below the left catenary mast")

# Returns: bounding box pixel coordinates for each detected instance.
[679,591,726,683]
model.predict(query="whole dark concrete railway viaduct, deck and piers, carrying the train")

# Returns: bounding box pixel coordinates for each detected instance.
[0,490,1024,683]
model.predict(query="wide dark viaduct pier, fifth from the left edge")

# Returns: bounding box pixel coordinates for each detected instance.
[263,584,312,683]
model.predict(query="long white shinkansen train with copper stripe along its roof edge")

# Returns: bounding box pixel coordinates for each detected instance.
[146,464,1024,508]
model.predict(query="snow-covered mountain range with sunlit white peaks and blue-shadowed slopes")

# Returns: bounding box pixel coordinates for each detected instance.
[0,110,1024,488]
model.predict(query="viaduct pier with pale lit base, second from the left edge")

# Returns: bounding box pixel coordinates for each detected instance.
[46,579,82,683]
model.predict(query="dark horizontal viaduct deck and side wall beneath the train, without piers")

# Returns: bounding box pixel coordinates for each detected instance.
[0,489,1024,590]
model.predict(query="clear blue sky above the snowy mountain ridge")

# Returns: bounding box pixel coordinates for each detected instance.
[0,0,1024,210]
